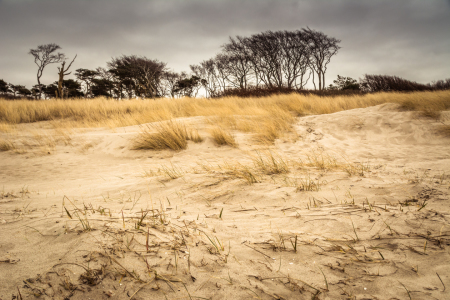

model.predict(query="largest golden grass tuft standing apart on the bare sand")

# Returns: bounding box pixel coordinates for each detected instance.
[132,120,203,151]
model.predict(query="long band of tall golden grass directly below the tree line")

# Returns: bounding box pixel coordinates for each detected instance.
[0,91,450,127]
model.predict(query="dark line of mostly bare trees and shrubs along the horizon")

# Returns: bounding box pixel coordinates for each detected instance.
[0,28,450,99]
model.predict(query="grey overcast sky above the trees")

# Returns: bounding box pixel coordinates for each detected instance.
[0,0,450,88]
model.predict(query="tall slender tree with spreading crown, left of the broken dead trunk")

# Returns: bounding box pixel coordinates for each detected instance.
[29,43,65,99]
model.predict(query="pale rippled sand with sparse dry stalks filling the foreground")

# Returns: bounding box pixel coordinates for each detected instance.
[0,104,450,300]
